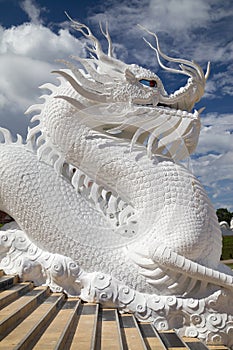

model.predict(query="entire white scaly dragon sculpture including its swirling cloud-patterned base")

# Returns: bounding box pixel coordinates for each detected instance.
[0,20,233,347]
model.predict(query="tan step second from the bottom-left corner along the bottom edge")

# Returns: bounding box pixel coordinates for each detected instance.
[33,299,78,350]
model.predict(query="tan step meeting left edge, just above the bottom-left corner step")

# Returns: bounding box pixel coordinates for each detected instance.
[0,286,49,340]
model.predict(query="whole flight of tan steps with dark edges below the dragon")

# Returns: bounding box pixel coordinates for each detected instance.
[0,271,227,350]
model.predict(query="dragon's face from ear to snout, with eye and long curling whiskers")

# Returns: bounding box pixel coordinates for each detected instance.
[121,26,210,111]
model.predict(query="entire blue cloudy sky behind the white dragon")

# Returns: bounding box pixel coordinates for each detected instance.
[0,0,233,211]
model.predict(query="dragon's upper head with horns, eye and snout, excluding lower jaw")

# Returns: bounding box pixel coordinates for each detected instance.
[57,18,210,111]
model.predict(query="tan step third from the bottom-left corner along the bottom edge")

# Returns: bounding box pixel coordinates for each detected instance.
[70,303,99,350]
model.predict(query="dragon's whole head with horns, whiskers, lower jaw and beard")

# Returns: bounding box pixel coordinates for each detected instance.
[51,18,210,159]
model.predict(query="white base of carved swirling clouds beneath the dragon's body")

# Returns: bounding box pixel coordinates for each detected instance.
[0,223,233,349]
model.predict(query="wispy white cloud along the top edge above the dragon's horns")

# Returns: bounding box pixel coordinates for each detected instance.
[92,0,211,35]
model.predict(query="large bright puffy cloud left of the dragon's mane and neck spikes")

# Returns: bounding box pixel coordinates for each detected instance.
[0,23,83,135]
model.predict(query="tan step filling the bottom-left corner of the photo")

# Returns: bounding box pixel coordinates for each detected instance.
[0,293,65,350]
